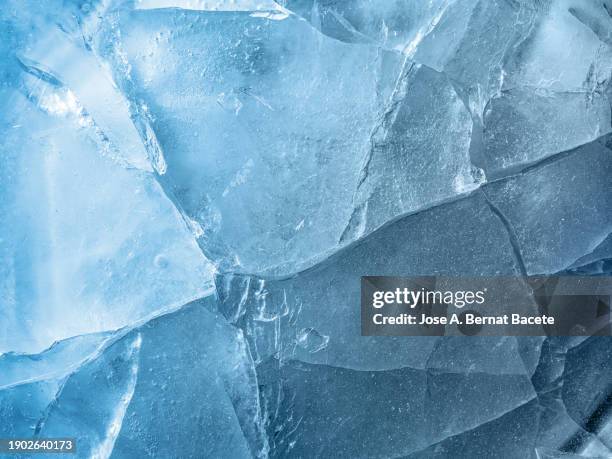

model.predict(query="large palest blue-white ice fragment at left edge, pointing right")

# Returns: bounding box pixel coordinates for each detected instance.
[0,87,212,352]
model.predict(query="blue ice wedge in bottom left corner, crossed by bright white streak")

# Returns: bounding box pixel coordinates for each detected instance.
[0,298,267,458]
